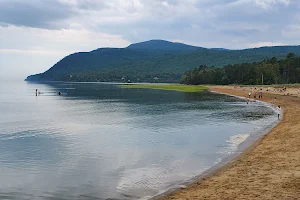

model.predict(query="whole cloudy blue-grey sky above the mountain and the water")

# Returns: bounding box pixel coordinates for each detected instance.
[0,0,300,80]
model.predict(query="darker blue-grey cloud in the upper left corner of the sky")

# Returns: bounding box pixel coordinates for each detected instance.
[0,0,109,29]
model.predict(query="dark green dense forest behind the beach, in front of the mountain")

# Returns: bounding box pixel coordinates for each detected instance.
[181,53,300,85]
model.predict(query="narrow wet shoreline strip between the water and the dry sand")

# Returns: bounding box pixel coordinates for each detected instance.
[150,90,281,200]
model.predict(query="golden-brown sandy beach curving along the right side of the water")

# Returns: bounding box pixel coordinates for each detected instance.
[159,86,300,200]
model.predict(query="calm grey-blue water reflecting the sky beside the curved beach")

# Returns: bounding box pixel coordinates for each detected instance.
[0,82,276,200]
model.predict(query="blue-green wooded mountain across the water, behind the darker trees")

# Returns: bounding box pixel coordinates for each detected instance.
[26,40,300,82]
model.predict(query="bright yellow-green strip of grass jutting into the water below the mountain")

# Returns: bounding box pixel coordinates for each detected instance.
[119,83,207,92]
